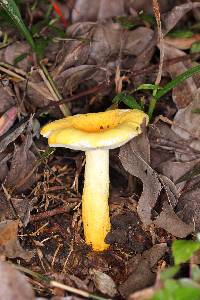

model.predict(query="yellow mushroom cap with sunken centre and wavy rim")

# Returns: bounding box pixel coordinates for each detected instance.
[41,109,148,151]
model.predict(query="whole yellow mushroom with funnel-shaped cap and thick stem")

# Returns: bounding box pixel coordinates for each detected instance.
[41,109,148,251]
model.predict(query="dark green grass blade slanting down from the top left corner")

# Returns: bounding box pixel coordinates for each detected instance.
[0,0,35,50]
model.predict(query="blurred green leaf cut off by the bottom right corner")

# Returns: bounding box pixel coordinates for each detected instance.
[153,279,200,300]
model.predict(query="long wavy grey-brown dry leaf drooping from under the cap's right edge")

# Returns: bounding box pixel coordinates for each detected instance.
[120,133,193,237]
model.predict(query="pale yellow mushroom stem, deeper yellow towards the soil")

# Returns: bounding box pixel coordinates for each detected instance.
[82,149,110,251]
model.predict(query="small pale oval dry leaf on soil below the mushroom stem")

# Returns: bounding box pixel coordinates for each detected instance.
[89,269,117,297]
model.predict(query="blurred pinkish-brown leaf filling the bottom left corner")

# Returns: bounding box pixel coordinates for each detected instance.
[0,262,35,300]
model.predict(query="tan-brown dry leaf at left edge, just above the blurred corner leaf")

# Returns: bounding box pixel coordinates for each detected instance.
[0,220,33,261]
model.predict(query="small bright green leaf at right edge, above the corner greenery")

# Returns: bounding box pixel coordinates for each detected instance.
[172,240,200,265]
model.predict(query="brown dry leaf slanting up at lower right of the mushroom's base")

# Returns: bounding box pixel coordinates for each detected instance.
[119,243,168,299]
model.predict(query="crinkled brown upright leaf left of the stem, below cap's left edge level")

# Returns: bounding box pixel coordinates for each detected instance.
[5,134,36,192]
